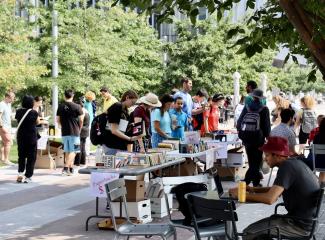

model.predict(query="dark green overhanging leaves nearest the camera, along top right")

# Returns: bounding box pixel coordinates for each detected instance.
[121,0,325,80]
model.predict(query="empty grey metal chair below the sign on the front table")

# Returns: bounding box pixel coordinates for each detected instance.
[105,178,177,240]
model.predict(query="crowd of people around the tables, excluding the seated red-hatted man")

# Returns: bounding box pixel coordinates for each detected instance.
[0,77,323,186]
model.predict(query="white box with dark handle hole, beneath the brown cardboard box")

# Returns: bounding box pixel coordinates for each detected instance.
[112,199,152,223]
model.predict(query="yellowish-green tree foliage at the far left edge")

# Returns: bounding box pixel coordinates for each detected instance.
[0,0,47,94]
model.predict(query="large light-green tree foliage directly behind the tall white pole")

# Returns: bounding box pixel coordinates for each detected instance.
[36,0,163,98]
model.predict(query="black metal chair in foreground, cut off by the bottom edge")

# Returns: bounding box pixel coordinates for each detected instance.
[187,194,239,240]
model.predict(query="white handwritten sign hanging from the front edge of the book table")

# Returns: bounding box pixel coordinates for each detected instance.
[90,172,119,198]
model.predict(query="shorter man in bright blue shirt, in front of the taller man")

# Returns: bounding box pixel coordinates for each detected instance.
[169,97,188,140]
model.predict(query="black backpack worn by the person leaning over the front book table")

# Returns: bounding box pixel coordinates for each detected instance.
[90,113,108,146]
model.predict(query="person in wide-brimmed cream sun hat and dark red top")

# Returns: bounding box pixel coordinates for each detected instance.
[131,92,161,152]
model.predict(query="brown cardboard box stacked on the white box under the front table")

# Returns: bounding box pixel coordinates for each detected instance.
[125,180,145,202]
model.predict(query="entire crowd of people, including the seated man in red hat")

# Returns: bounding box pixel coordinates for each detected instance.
[0,78,325,239]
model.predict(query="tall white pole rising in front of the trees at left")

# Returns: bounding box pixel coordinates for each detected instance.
[52,10,59,129]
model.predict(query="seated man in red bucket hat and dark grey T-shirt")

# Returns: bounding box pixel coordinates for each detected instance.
[229,137,319,240]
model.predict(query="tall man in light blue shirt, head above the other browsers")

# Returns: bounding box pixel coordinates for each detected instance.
[173,77,203,131]
